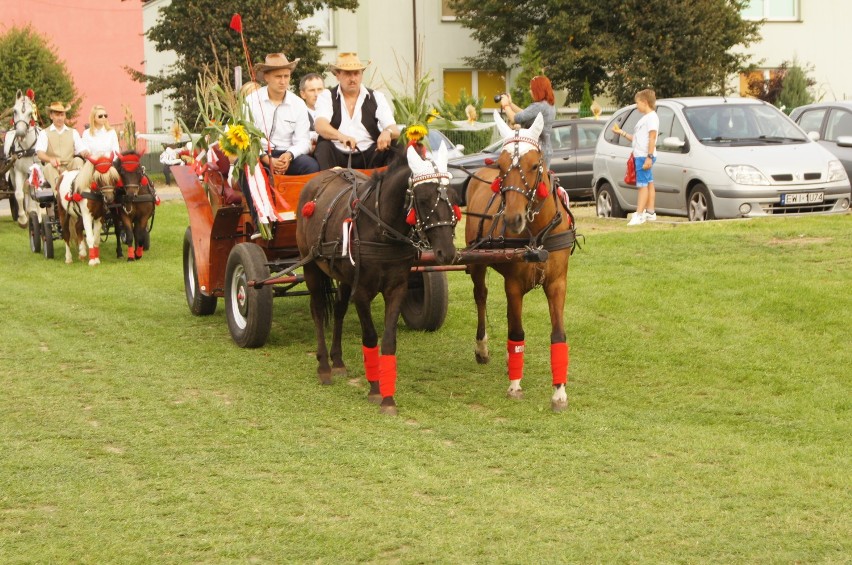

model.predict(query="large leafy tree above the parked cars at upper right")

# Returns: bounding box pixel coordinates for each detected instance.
[451,0,759,104]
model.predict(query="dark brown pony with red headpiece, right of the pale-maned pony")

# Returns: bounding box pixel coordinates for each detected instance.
[116,151,159,261]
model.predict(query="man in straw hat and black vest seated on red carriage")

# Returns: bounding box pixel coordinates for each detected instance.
[314,53,399,169]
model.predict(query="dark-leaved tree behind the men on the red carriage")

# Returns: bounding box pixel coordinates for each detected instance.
[127,0,358,125]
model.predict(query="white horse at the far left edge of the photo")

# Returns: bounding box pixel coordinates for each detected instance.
[3,90,39,228]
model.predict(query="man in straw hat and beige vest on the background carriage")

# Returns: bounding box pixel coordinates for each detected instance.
[35,102,89,188]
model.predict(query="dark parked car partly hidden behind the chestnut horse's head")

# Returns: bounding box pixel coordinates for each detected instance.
[449,119,604,202]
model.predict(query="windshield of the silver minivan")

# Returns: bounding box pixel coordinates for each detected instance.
[683,103,808,146]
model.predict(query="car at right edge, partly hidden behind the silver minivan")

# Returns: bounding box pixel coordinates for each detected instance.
[790,102,852,178]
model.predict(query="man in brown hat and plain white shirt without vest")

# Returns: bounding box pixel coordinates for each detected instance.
[246,53,319,175]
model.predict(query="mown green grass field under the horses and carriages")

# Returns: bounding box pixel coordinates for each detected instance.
[0,201,852,563]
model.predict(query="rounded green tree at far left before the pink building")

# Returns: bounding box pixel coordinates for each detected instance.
[0,26,82,126]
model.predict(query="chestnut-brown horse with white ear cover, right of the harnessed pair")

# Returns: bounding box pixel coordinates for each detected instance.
[465,112,576,412]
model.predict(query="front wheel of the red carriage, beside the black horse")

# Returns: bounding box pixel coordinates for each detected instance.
[225,243,273,347]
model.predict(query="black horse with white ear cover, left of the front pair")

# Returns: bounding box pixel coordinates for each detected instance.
[296,144,461,415]
